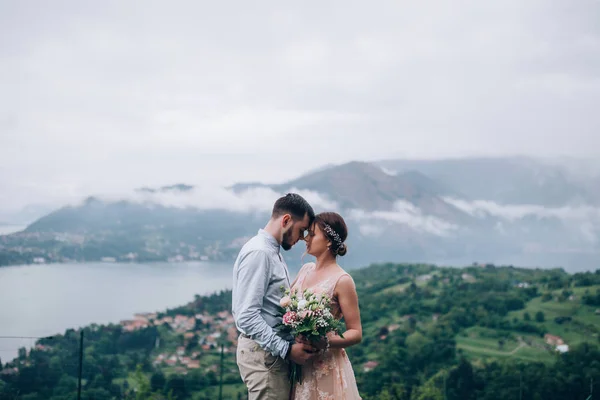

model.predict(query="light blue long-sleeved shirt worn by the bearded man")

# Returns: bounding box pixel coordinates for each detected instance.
[232,229,293,358]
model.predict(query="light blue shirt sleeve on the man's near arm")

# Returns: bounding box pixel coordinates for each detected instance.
[232,250,290,358]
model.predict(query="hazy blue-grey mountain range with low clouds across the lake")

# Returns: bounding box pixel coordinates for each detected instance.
[0,158,600,270]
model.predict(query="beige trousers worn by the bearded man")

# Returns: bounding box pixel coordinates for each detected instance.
[237,336,290,400]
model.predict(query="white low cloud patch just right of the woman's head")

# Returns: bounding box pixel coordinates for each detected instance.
[348,200,458,236]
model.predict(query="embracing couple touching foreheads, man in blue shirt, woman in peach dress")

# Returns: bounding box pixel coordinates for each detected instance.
[232,193,362,400]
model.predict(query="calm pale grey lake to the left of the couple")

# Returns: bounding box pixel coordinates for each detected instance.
[0,262,233,363]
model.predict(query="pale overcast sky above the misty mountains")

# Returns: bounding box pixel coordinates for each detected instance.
[0,0,600,209]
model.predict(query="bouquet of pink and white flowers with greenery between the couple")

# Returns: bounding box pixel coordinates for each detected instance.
[276,287,344,382]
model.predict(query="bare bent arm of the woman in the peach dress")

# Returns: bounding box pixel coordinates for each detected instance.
[329,275,362,349]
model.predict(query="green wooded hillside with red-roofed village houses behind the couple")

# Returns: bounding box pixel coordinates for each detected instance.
[0,263,600,400]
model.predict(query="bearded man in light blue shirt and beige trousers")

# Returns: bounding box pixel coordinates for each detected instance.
[232,193,315,400]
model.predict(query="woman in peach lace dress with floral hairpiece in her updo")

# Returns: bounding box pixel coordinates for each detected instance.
[291,212,362,400]
